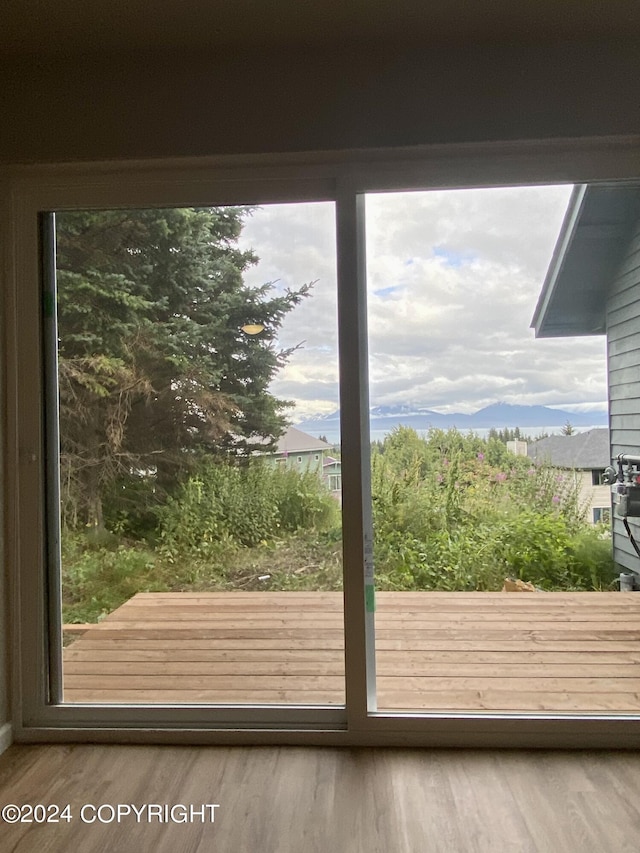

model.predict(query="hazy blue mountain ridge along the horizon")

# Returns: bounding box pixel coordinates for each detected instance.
[296,403,608,433]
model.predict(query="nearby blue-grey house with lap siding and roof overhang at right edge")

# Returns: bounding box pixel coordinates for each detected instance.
[532,184,640,572]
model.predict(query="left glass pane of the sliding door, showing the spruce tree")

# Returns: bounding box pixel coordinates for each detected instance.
[55,202,344,706]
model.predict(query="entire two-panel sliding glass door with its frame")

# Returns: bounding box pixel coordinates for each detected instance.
[8,146,637,744]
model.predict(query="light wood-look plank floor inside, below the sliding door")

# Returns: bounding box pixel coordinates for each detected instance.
[0,745,640,853]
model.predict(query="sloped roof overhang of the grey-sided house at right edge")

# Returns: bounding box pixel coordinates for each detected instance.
[531,184,640,338]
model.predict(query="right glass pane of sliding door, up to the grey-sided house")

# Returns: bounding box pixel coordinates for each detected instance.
[366,187,640,714]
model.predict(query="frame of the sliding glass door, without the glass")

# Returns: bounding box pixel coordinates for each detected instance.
[4,137,640,747]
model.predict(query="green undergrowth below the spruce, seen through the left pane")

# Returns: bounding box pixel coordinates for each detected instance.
[62,459,342,622]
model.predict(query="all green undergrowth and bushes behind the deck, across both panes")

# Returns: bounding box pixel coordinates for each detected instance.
[63,427,614,622]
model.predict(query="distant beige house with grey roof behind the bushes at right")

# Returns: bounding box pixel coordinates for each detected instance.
[527,429,611,524]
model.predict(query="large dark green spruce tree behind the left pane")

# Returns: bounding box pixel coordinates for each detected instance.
[56,207,310,527]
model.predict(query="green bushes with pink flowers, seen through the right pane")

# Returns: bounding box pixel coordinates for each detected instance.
[372,428,614,590]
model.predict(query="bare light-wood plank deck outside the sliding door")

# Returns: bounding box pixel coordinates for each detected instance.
[64,592,640,713]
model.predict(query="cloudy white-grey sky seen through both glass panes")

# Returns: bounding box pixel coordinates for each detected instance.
[241,186,607,420]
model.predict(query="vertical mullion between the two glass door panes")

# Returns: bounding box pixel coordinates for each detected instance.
[336,184,376,729]
